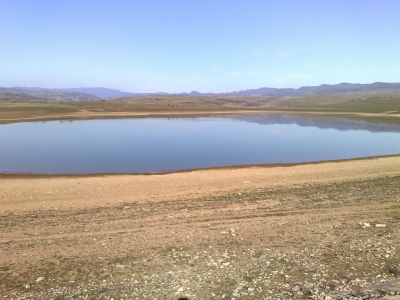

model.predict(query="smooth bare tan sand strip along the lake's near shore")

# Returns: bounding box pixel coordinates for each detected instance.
[0,156,400,213]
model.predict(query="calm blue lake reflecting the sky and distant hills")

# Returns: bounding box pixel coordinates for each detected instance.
[0,114,400,174]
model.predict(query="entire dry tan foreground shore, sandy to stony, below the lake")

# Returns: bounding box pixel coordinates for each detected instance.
[0,156,400,300]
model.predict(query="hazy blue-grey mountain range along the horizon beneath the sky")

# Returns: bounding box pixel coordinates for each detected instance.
[0,82,400,101]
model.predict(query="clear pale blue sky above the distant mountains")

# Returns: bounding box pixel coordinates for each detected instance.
[0,0,400,92]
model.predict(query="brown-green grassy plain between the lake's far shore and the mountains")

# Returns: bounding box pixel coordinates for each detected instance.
[0,94,400,124]
